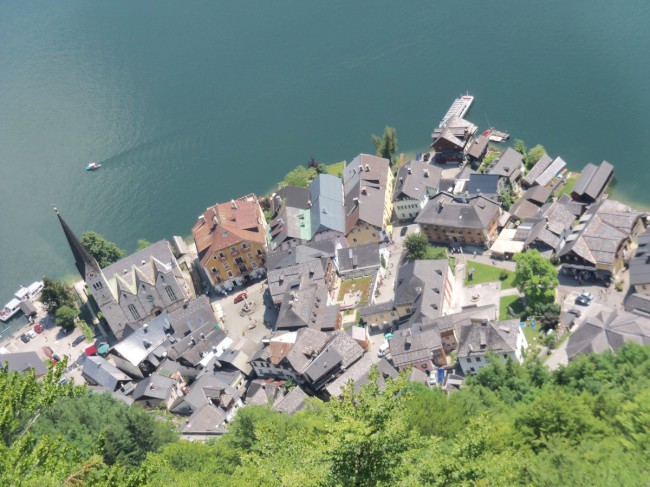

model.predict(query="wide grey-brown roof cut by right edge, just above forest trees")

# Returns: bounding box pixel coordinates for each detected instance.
[566,311,650,359]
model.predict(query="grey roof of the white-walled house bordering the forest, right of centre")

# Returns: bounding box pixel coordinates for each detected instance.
[457,320,521,358]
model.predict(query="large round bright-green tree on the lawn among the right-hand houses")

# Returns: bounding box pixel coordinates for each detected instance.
[513,250,559,307]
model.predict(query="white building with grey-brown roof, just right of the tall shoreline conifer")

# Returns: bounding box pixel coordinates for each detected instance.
[393,161,442,221]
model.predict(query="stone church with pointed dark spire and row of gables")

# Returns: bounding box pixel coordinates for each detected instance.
[57,212,191,339]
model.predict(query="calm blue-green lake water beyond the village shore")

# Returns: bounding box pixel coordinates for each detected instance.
[0,0,650,312]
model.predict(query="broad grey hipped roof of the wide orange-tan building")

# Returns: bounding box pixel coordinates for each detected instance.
[415,192,500,229]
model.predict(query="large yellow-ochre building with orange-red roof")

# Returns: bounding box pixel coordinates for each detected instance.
[192,194,268,289]
